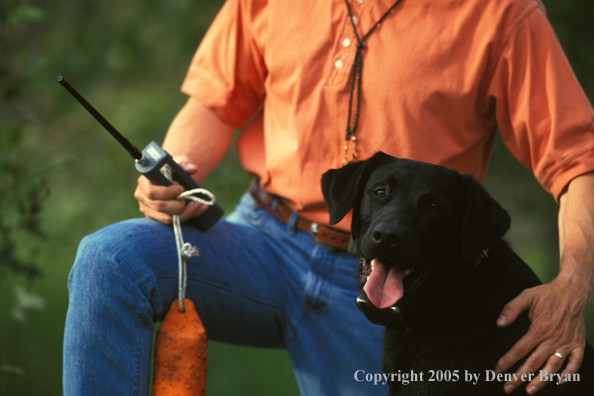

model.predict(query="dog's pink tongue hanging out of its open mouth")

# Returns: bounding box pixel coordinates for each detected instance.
[363,259,404,308]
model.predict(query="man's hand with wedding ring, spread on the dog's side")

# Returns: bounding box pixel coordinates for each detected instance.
[495,270,589,395]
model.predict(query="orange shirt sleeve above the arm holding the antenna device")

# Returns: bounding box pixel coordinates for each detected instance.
[182,0,267,128]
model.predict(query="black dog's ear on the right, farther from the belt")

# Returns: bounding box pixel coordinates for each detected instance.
[462,174,511,263]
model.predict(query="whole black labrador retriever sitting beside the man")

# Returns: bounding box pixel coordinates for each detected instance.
[322,152,594,396]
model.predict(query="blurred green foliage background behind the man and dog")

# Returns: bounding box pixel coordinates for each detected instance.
[0,0,594,395]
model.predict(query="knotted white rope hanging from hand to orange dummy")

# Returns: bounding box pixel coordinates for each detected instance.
[173,188,215,312]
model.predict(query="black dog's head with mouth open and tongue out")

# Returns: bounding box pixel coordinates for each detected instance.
[322,152,510,328]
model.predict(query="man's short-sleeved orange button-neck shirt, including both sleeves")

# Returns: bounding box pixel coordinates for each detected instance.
[182,0,594,229]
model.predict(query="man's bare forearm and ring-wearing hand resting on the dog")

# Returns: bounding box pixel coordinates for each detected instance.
[495,172,594,395]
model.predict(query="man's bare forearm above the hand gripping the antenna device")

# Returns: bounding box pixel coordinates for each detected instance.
[163,98,234,182]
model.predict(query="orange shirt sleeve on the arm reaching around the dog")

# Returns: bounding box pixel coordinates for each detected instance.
[488,3,594,200]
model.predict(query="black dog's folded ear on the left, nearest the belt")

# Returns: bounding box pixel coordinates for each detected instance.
[322,151,393,225]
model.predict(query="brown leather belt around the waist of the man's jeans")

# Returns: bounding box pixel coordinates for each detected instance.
[249,180,351,250]
